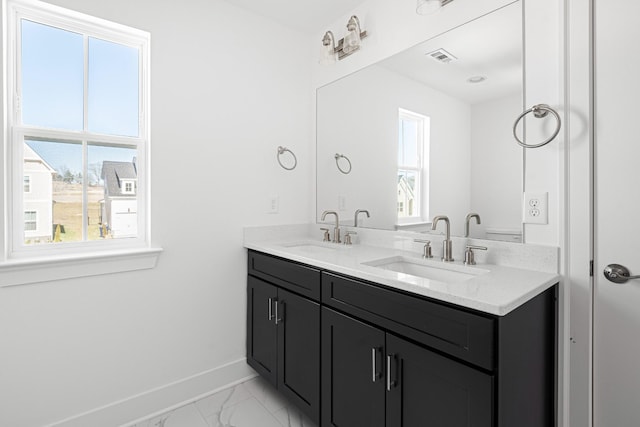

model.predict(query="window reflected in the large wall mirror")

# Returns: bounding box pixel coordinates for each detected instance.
[397,109,430,224]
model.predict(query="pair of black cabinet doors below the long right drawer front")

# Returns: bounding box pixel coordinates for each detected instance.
[322,308,493,427]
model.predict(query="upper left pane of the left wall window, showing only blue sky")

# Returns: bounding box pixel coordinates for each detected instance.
[21,19,84,130]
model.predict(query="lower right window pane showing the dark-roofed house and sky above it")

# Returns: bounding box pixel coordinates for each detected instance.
[88,145,138,240]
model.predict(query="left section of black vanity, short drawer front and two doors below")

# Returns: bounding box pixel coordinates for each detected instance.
[247,254,320,422]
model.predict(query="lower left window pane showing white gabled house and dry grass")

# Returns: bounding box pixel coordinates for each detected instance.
[23,140,83,244]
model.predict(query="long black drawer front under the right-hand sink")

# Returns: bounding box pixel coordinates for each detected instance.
[322,273,495,370]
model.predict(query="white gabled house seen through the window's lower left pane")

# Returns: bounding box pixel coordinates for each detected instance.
[23,144,56,243]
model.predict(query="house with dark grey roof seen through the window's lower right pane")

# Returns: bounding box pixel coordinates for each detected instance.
[100,159,138,237]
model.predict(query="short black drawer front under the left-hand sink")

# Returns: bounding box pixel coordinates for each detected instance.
[249,251,320,301]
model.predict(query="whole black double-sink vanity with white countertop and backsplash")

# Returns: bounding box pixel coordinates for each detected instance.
[245,226,559,427]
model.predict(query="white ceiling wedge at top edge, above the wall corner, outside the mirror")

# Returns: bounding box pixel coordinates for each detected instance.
[225,0,364,34]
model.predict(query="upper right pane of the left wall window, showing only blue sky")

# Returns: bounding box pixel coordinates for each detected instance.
[89,37,139,136]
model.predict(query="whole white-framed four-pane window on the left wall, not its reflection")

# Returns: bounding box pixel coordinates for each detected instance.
[5,0,149,256]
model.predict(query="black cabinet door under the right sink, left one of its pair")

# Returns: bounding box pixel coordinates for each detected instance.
[322,308,385,427]
